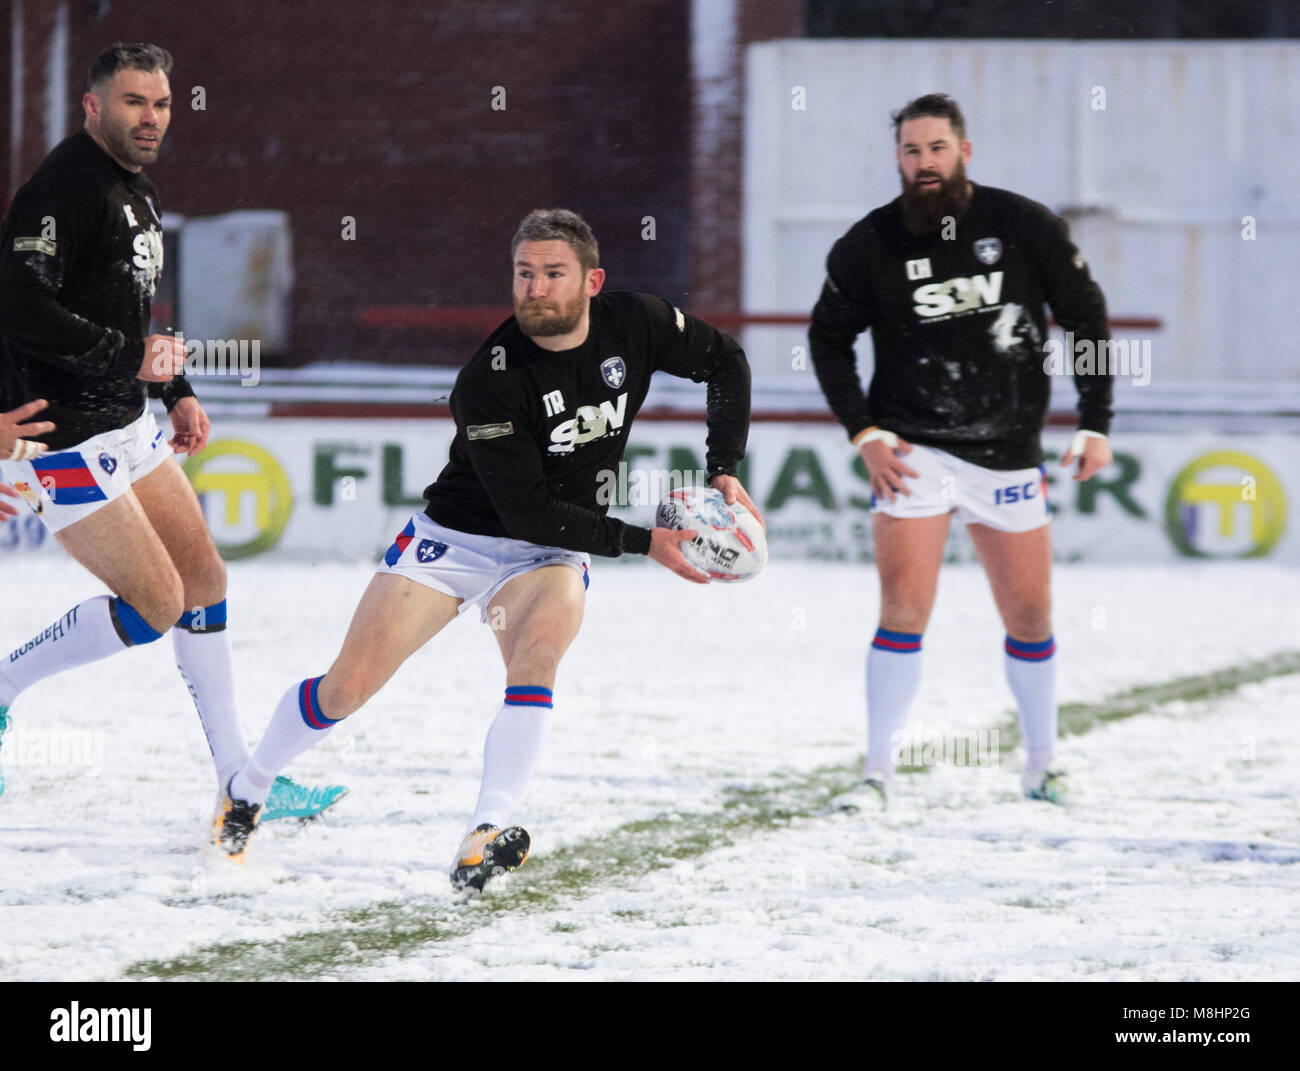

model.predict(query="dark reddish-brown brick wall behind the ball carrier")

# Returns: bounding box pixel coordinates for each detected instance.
[0,0,802,364]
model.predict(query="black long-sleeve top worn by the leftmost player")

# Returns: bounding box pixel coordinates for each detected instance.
[0,130,194,450]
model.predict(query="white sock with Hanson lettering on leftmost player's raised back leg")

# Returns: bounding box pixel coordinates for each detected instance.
[0,595,163,706]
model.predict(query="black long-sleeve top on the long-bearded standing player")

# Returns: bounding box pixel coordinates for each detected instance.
[809,183,1114,469]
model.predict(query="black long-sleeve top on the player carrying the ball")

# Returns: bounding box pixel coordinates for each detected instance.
[424,291,750,558]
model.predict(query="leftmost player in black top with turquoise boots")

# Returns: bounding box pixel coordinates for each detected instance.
[0,44,342,816]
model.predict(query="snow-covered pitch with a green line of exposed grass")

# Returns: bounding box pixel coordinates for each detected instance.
[0,561,1300,980]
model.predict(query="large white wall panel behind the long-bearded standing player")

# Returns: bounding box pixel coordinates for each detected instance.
[742,40,1300,383]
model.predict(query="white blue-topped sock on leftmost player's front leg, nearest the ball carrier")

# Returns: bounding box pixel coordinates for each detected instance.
[172,599,248,788]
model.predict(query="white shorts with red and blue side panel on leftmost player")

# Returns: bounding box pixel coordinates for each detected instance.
[0,409,172,532]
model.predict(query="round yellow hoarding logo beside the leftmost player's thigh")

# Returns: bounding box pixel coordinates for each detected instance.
[185,439,294,560]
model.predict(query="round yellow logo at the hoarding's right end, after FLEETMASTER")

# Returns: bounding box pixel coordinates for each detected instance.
[1165,450,1287,558]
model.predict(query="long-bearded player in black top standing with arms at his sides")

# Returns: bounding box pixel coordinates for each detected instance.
[810,94,1112,810]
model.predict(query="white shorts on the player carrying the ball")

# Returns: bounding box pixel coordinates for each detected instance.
[378,513,592,621]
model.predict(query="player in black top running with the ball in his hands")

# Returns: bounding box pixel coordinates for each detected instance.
[215,209,758,889]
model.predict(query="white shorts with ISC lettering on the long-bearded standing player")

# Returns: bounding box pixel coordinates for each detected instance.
[871,445,1052,532]
